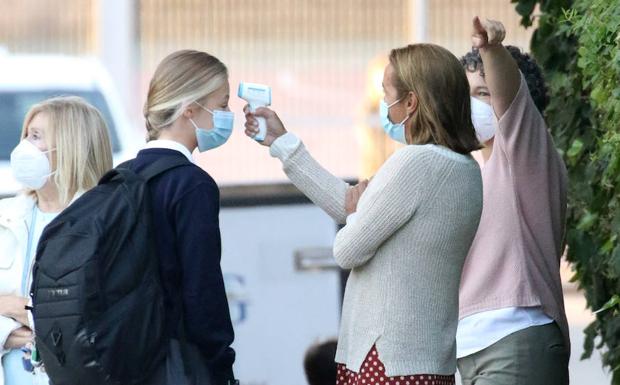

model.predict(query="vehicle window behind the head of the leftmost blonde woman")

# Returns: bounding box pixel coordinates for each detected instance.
[0,90,121,160]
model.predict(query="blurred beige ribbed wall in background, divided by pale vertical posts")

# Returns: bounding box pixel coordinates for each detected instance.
[0,0,531,183]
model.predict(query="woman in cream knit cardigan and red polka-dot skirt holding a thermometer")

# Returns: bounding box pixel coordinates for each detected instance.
[246,44,482,385]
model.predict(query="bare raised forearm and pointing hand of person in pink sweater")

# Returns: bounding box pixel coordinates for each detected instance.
[471,16,521,118]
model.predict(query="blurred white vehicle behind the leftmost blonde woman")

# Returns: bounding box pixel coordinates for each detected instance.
[0,51,140,197]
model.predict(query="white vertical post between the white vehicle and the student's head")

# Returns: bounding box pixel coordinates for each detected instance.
[96,0,138,121]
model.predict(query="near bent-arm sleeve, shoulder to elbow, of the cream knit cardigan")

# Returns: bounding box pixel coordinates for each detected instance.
[334,147,430,269]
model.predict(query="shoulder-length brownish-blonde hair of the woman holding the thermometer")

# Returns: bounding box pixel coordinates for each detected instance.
[390,44,480,154]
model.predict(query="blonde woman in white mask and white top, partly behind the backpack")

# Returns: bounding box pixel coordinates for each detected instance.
[0,97,112,385]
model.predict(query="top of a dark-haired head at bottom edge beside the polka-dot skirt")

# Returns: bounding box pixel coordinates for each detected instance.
[304,339,338,385]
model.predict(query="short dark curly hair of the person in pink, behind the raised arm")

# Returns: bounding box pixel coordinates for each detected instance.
[461,45,549,114]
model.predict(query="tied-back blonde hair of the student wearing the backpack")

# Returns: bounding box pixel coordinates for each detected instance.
[143,50,228,141]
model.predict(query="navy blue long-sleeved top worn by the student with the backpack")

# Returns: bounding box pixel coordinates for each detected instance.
[131,148,235,385]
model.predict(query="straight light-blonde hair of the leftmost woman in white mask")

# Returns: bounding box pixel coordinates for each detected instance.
[21,96,112,204]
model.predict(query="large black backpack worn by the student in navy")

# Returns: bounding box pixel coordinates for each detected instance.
[30,159,187,385]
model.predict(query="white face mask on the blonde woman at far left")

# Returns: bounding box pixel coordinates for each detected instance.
[11,139,54,190]
